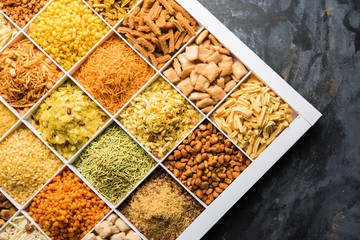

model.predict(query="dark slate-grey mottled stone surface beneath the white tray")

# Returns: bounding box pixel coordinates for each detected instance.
[200,0,360,240]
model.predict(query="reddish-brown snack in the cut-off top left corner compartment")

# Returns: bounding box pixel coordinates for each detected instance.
[0,0,49,28]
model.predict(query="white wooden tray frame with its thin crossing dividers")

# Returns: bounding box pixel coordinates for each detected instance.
[0,0,321,240]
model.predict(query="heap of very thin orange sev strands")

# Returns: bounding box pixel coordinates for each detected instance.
[74,36,155,114]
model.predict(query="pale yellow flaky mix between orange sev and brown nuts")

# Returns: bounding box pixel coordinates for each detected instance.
[120,78,201,158]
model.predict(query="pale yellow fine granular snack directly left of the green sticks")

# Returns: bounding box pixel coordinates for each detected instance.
[0,126,63,204]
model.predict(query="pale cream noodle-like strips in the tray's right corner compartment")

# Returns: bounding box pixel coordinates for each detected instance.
[211,75,292,158]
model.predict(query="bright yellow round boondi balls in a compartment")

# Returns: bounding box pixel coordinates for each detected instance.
[29,0,109,70]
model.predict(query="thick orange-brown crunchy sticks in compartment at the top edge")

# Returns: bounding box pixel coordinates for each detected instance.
[117,0,199,68]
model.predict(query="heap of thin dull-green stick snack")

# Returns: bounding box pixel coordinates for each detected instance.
[74,124,156,204]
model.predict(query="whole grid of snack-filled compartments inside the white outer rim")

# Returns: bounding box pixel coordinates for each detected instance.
[0,0,296,240]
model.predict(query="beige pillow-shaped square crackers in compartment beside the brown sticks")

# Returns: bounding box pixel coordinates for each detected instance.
[164,30,248,114]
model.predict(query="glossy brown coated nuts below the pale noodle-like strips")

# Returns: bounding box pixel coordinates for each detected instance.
[165,123,251,205]
